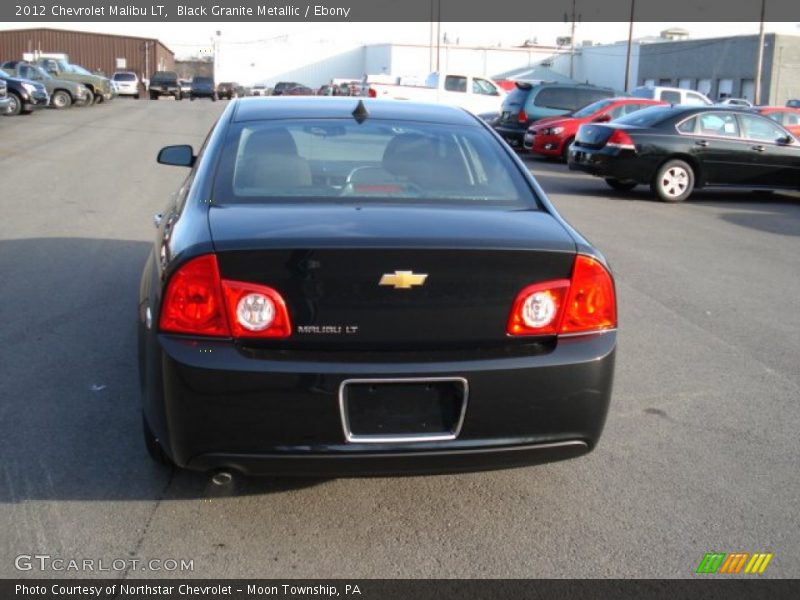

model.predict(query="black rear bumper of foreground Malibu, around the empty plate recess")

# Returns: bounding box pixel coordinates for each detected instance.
[145,331,616,476]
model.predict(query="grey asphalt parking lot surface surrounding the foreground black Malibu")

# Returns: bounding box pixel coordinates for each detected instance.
[0,99,800,578]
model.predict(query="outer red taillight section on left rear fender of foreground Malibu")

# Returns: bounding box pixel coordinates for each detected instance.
[159,254,230,337]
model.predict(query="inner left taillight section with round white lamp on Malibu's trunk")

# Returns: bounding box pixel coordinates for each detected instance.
[222,279,292,338]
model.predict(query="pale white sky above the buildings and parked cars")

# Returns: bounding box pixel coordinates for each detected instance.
[0,21,800,58]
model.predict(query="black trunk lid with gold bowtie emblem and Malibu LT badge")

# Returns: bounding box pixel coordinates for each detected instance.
[209,204,575,349]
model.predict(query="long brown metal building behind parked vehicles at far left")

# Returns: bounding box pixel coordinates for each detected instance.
[0,27,175,79]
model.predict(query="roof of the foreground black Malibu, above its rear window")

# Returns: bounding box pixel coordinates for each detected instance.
[233,96,478,126]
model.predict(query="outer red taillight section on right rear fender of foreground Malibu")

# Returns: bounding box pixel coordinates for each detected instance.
[559,254,617,333]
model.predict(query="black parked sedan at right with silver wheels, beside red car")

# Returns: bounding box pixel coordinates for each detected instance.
[569,105,800,202]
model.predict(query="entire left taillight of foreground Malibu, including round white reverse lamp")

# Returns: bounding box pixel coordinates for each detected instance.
[159,254,292,338]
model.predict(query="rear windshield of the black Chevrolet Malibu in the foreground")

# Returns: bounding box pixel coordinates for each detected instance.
[214,119,536,208]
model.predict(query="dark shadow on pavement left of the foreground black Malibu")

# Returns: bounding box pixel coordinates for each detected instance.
[0,238,325,503]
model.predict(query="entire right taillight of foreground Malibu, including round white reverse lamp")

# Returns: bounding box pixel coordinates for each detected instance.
[506,254,617,336]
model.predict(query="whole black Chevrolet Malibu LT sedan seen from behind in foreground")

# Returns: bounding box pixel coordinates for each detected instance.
[138,98,617,476]
